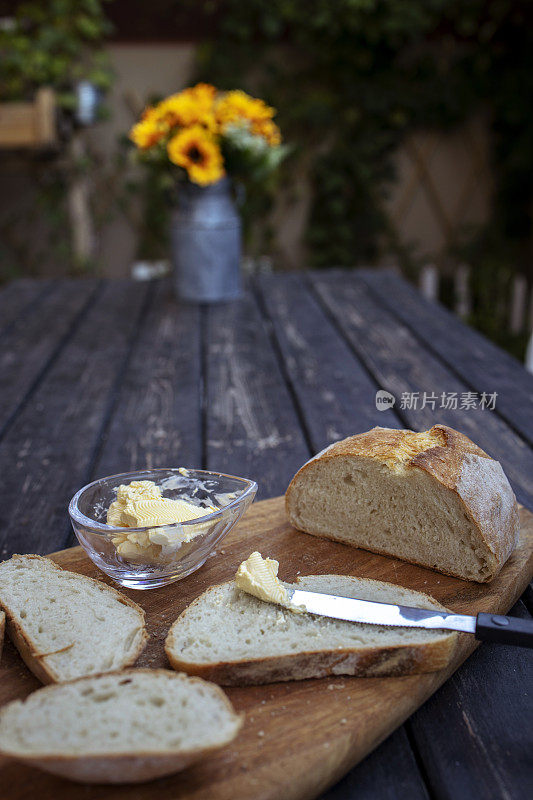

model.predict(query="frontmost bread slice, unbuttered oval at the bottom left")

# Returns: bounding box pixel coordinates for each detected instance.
[0,669,242,783]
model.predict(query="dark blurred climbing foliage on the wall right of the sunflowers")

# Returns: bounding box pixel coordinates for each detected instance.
[195,0,533,356]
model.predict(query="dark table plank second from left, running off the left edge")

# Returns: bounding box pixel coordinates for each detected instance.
[0,280,97,436]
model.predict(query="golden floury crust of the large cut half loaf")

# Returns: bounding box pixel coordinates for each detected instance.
[285,425,520,583]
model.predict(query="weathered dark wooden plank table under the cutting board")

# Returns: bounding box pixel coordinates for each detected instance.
[0,271,533,800]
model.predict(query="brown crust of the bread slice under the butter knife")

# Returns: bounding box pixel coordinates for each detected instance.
[165,576,458,686]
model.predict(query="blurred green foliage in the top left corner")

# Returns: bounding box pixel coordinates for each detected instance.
[0,0,111,108]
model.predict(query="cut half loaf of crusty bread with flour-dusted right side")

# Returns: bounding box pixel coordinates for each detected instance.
[285,425,519,583]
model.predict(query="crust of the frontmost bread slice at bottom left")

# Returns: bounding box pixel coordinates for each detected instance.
[0,669,244,784]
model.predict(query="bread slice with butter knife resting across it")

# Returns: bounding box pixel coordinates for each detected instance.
[165,575,457,686]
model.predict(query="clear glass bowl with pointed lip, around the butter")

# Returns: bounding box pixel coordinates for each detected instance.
[68,467,257,589]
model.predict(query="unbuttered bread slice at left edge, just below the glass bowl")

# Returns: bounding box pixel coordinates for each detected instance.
[0,555,148,683]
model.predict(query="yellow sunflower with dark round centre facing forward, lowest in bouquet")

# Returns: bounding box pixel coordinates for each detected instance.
[167,125,225,186]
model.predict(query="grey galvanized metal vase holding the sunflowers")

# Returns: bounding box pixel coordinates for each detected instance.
[171,178,242,303]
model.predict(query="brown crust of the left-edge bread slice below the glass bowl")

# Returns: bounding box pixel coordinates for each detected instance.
[0,554,148,684]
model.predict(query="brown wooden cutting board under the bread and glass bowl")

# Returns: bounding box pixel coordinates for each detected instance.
[0,498,533,800]
